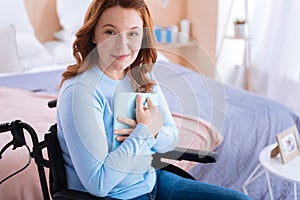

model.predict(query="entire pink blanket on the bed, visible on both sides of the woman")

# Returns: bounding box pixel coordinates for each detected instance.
[0,87,223,200]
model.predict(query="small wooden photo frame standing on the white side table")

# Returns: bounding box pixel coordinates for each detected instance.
[276,125,300,164]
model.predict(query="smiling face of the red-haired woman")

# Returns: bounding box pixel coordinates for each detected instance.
[93,6,143,79]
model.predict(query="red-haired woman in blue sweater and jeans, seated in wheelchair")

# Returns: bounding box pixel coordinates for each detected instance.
[57,0,251,199]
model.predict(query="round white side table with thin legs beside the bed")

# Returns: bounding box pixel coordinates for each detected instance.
[243,144,300,200]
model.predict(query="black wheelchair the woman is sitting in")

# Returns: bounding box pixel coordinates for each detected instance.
[0,100,217,200]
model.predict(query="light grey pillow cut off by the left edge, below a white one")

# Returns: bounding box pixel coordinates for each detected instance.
[0,25,22,73]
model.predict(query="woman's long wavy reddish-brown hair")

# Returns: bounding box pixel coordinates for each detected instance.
[60,0,157,92]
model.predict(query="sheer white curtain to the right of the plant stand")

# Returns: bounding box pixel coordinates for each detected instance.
[250,0,300,113]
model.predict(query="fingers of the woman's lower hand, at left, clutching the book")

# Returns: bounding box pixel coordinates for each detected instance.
[114,117,136,142]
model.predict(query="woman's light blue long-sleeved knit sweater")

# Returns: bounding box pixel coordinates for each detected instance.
[57,66,178,199]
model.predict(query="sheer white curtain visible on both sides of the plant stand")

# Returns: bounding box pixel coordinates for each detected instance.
[217,0,300,113]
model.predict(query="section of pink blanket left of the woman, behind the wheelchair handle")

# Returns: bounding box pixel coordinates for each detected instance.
[0,87,56,200]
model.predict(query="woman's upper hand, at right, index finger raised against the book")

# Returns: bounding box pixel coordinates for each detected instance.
[136,94,163,138]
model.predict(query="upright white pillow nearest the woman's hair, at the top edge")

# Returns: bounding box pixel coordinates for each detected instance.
[55,0,92,41]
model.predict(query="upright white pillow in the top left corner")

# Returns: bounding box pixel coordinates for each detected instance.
[0,0,34,34]
